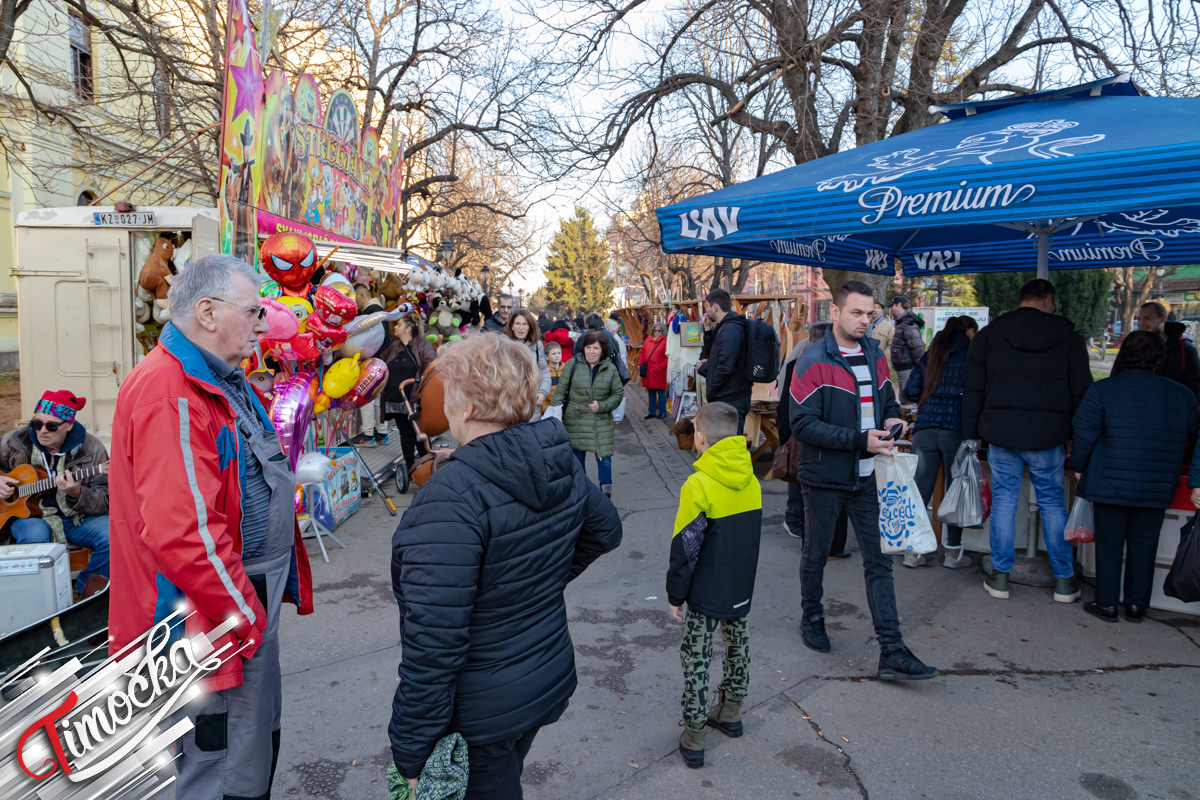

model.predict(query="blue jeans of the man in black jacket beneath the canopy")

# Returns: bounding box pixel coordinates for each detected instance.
[988,445,1075,578]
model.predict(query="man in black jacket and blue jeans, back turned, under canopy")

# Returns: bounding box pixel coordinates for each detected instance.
[962,278,1092,603]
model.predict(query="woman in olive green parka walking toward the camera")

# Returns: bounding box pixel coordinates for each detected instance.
[551,331,625,497]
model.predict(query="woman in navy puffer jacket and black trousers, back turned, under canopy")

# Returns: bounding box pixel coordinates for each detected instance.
[1070,331,1200,622]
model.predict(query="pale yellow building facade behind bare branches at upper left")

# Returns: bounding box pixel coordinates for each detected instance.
[0,0,214,369]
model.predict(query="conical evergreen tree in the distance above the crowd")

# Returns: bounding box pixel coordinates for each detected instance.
[544,206,616,315]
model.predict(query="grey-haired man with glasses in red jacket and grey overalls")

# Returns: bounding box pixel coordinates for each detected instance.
[109,255,312,800]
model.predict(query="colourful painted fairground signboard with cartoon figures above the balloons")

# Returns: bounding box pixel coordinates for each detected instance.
[220,0,403,256]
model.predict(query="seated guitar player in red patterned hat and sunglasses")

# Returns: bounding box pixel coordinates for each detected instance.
[0,390,108,597]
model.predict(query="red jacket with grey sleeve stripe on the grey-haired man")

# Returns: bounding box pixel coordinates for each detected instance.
[108,324,312,691]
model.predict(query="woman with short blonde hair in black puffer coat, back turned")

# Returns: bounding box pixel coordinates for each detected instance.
[388,336,622,799]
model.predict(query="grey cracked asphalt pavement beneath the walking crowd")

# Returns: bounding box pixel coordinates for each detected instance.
[275,387,1200,800]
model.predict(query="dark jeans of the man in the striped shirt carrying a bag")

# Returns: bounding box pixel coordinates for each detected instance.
[800,475,904,650]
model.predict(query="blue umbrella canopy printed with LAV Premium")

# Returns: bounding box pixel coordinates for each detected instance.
[658,77,1200,276]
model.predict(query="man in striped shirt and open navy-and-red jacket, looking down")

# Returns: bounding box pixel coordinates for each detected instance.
[787,281,937,680]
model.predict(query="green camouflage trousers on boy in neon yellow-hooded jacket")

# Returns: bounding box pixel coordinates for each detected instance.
[679,608,750,729]
